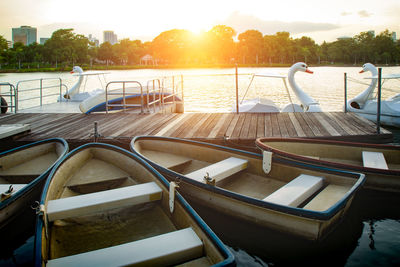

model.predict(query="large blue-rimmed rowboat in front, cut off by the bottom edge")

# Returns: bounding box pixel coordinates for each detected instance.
[35,143,234,266]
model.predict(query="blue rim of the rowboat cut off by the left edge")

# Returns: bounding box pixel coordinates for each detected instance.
[0,138,69,210]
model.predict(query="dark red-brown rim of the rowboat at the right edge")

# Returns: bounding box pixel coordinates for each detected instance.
[256,137,400,175]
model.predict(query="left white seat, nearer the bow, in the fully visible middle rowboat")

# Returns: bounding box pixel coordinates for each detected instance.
[185,157,247,182]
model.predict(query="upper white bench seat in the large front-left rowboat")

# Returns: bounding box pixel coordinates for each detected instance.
[47,182,162,221]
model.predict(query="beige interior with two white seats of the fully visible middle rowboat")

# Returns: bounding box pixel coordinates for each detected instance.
[134,139,357,214]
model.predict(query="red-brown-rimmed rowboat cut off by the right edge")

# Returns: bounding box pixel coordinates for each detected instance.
[256,138,400,192]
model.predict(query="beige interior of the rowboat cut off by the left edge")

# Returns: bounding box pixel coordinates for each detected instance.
[0,142,64,199]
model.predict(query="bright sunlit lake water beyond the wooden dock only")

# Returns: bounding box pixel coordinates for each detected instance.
[0,67,400,112]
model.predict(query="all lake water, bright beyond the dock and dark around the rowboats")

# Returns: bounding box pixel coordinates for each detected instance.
[0,67,400,266]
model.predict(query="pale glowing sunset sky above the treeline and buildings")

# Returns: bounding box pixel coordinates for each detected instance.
[0,0,400,44]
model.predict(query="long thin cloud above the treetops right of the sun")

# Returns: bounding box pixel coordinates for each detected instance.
[219,11,340,34]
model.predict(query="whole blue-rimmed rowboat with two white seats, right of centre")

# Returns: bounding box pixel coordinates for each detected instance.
[131,136,364,240]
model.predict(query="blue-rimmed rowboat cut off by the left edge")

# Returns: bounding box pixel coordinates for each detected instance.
[0,138,68,229]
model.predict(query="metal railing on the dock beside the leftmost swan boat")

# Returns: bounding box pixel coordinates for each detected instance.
[16,78,68,111]
